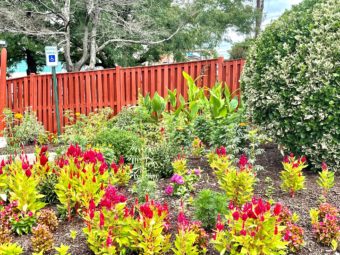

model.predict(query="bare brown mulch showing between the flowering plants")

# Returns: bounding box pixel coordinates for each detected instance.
[11,144,340,255]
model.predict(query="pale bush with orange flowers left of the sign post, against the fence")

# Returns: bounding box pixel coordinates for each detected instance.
[3,109,46,153]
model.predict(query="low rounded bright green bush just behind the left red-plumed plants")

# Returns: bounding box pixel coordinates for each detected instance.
[93,128,143,164]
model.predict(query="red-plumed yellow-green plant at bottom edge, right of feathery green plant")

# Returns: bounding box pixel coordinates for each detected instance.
[211,198,288,255]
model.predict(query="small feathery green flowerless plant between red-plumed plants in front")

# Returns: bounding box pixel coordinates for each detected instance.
[194,189,227,229]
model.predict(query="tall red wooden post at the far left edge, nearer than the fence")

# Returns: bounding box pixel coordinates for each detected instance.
[0,48,7,136]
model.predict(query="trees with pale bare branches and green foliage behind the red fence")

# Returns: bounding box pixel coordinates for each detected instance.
[0,0,255,72]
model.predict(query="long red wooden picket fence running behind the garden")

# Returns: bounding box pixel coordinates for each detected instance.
[0,58,244,132]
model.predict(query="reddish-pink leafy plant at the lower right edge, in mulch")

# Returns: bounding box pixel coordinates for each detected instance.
[310,203,340,250]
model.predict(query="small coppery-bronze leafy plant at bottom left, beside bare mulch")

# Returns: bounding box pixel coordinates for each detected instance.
[31,225,53,253]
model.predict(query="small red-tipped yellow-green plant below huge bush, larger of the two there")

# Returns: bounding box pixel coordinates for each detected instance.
[281,153,307,197]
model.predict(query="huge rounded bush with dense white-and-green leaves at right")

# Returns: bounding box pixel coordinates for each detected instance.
[241,0,340,171]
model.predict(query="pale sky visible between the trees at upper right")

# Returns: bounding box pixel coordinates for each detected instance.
[217,0,302,58]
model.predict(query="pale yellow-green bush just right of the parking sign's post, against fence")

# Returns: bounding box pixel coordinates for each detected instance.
[61,108,113,148]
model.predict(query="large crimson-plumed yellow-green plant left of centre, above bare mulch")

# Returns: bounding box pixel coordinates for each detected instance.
[55,145,110,219]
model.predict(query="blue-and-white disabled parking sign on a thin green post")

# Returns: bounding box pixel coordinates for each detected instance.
[45,46,61,136]
